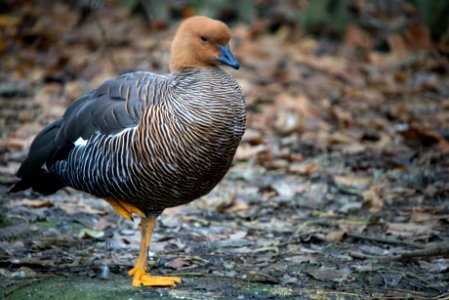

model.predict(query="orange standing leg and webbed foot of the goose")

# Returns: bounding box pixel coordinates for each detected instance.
[128,217,181,287]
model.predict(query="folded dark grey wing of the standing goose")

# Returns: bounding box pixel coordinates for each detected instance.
[17,72,165,182]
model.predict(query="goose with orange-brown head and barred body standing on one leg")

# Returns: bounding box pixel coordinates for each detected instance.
[10,16,246,287]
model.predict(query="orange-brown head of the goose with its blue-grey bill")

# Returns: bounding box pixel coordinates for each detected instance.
[170,16,240,72]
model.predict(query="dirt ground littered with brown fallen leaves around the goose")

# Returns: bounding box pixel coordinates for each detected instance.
[0,2,449,299]
